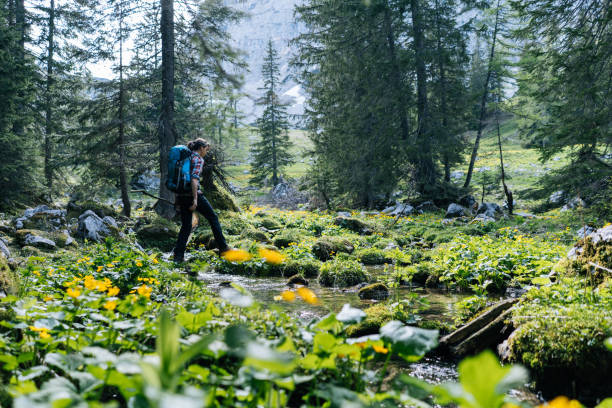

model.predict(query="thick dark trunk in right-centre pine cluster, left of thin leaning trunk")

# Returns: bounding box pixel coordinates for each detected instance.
[410,0,436,193]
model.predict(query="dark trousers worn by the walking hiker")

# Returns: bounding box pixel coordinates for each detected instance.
[174,193,227,259]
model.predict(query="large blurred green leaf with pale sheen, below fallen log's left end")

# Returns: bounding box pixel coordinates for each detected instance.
[380,320,438,362]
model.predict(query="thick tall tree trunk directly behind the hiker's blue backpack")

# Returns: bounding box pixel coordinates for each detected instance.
[156,0,176,218]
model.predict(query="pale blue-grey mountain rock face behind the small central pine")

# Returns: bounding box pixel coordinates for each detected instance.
[224,0,306,122]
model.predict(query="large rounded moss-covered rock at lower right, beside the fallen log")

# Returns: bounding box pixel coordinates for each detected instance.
[508,308,612,398]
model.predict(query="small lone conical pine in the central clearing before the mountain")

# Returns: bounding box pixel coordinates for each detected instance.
[251,40,293,186]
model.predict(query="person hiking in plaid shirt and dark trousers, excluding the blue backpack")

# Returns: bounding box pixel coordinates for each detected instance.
[174,138,229,263]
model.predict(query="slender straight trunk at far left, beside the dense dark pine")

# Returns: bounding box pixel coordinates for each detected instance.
[44,0,55,190]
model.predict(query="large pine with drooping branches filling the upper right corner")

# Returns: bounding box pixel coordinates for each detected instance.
[512,0,612,206]
